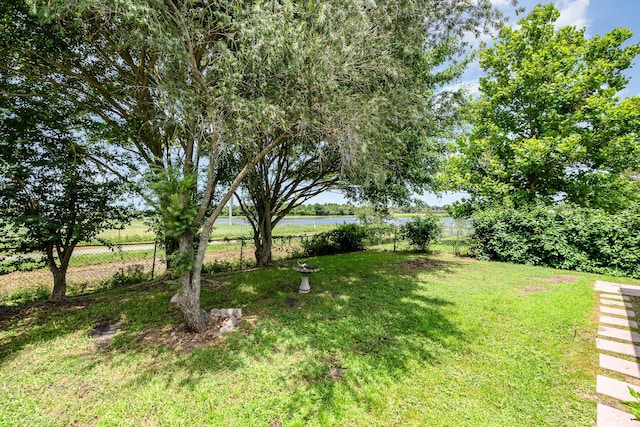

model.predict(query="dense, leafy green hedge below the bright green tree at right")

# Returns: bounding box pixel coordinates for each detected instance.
[472,204,640,277]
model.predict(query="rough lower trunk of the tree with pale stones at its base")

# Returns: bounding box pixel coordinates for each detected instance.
[171,234,211,332]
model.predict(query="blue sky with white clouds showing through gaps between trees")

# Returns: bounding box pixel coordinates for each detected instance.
[310,0,640,206]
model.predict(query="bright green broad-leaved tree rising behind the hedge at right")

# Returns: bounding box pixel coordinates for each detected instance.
[449,5,640,211]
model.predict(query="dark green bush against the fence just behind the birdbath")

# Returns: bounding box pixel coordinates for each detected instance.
[304,224,367,256]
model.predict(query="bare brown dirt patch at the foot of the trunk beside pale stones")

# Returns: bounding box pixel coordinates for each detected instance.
[138,317,226,354]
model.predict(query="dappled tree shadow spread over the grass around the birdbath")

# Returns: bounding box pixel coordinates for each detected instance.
[0,253,466,422]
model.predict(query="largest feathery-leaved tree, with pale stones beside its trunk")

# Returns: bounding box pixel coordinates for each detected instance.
[0,0,504,330]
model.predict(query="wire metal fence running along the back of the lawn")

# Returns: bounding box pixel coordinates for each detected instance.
[0,223,471,301]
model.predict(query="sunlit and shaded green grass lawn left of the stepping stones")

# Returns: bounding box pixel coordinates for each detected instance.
[0,252,633,426]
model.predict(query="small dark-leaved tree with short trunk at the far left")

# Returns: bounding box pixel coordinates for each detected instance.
[0,92,133,301]
